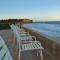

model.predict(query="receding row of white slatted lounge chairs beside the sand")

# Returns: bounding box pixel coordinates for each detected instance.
[10,24,43,60]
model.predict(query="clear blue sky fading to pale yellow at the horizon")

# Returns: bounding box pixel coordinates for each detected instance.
[0,0,60,21]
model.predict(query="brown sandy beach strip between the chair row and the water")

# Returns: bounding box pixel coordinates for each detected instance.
[24,28,60,60]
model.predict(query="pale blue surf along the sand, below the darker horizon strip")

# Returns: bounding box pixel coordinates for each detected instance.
[24,23,60,38]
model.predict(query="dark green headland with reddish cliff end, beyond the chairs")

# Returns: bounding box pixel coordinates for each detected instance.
[0,19,32,30]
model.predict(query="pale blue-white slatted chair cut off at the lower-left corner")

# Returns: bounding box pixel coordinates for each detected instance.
[0,36,13,60]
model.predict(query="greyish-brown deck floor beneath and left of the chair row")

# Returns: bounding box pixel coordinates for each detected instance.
[0,30,40,60]
